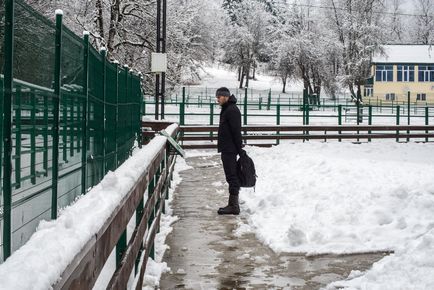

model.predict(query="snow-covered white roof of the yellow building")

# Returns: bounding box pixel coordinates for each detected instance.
[372,44,434,64]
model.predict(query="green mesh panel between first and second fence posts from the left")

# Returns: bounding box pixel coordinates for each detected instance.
[6,1,55,260]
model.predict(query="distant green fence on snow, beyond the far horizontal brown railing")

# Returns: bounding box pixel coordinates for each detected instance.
[144,89,434,125]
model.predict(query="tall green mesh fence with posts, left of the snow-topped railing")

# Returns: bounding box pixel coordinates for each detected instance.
[0,0,142,262]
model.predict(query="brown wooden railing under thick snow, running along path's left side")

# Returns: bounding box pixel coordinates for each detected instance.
[53,125,179,289]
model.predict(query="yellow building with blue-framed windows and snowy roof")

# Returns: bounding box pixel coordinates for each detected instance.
[364,45,434,104]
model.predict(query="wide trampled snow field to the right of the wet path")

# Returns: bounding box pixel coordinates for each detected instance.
[236,141,434,289]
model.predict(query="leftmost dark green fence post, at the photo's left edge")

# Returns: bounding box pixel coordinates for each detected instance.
[2,0,14,260]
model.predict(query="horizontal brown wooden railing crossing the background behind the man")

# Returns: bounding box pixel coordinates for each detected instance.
[177,125,434,149]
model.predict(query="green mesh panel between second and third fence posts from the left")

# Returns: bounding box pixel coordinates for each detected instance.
[58,27,86,207]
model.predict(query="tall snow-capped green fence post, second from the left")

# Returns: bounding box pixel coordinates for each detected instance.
[51,10,63,219]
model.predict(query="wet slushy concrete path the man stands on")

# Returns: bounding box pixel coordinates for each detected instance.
[160,155,385,289]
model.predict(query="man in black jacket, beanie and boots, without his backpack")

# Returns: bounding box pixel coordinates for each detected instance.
[216,87,242,215]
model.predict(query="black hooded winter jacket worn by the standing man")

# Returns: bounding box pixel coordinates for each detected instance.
[217,95,242,154]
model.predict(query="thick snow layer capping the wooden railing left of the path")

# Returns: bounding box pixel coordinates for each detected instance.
[0,124,177,289]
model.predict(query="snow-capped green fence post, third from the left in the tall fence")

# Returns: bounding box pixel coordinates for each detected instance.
[81,31,89,194]
